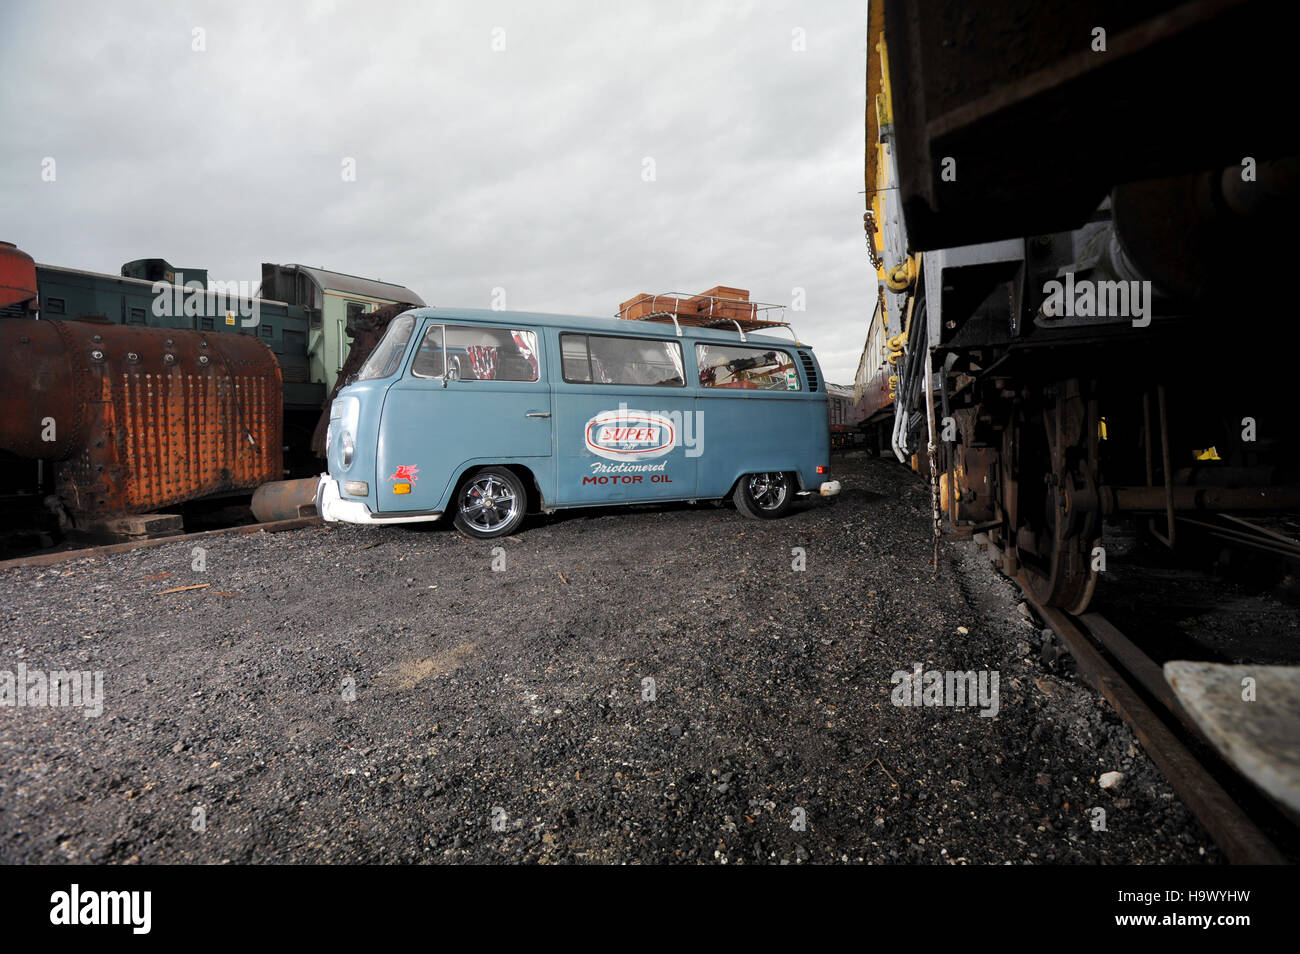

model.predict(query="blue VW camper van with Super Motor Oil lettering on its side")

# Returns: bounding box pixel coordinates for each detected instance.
[316,308,840,538]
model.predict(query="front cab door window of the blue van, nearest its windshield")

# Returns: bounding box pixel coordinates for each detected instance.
[411,325,541,381]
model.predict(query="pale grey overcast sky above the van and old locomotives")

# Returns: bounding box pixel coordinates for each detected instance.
[0,0,875,383]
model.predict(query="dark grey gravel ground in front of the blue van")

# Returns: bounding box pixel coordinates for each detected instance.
[0,458,1219,864]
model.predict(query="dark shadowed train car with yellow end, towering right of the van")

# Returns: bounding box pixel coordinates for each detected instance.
[863,0,1300,612]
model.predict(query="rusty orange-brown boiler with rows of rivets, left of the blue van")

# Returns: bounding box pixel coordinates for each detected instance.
[0,318,283,521]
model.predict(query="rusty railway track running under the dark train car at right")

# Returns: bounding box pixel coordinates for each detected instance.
[975,534,1294,864]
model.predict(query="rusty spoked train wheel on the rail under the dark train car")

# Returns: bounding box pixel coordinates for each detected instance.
[1013,380,1101,613]
